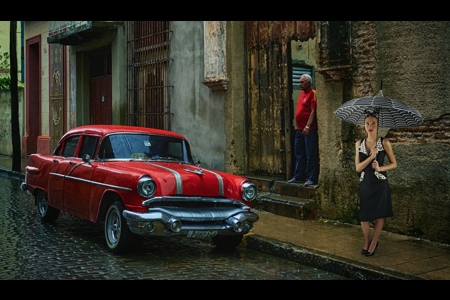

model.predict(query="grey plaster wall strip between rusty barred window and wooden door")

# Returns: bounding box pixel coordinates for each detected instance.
[169,21,225,171]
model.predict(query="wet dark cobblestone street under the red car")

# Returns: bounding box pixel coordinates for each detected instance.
[0,176,346,280]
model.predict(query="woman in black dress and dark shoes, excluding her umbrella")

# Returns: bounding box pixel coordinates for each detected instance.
[355,114,397,256]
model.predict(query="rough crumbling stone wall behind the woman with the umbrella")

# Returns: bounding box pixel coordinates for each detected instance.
[316,21,450,243]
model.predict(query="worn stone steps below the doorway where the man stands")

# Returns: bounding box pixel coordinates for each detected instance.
[245,176,319,220]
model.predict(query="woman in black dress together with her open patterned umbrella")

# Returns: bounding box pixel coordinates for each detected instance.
[334,89,422,256]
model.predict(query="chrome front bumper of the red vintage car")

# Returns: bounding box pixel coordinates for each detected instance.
[123,198,259,237]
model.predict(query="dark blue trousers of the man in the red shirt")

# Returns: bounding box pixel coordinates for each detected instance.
[294,129,319,183]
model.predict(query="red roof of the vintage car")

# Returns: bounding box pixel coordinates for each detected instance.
[63,125,186,140]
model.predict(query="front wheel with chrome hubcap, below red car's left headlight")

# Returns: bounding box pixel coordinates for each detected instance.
[105,201,132,253]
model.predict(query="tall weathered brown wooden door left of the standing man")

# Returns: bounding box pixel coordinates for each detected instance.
[247,21,292,179]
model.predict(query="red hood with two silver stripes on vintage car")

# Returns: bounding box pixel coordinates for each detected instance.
[106,161,233,198]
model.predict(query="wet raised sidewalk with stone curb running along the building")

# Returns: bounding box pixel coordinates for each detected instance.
[0,156,450,280]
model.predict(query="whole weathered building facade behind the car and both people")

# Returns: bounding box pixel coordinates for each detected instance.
[22,21,450,243]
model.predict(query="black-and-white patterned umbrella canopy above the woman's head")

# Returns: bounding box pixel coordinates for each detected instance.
[334,90,422,128]
